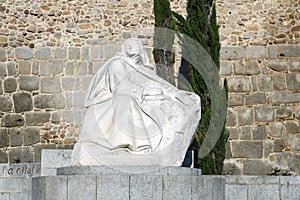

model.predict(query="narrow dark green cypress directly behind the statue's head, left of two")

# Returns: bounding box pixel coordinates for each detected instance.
[153,0,175,84]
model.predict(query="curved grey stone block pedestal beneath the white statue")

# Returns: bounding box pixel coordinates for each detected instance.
[32,166,225,200]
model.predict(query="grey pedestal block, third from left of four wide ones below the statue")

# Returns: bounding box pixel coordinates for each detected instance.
[129,175,162,200]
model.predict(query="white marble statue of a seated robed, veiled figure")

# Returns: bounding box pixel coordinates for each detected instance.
[72,38,200,166]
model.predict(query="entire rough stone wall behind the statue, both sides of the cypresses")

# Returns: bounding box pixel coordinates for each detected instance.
[0,0,300,175]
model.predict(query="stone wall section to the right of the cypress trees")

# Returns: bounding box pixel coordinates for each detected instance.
[217,0,300,175]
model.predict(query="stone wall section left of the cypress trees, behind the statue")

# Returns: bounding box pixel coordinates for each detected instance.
[0,0,154,163]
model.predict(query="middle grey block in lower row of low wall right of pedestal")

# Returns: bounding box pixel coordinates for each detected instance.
[249,185,280,200]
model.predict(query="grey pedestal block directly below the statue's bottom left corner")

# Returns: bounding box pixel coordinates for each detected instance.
[67,175,97,200]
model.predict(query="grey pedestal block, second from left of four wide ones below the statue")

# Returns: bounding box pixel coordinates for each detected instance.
[97,174,129,200]
